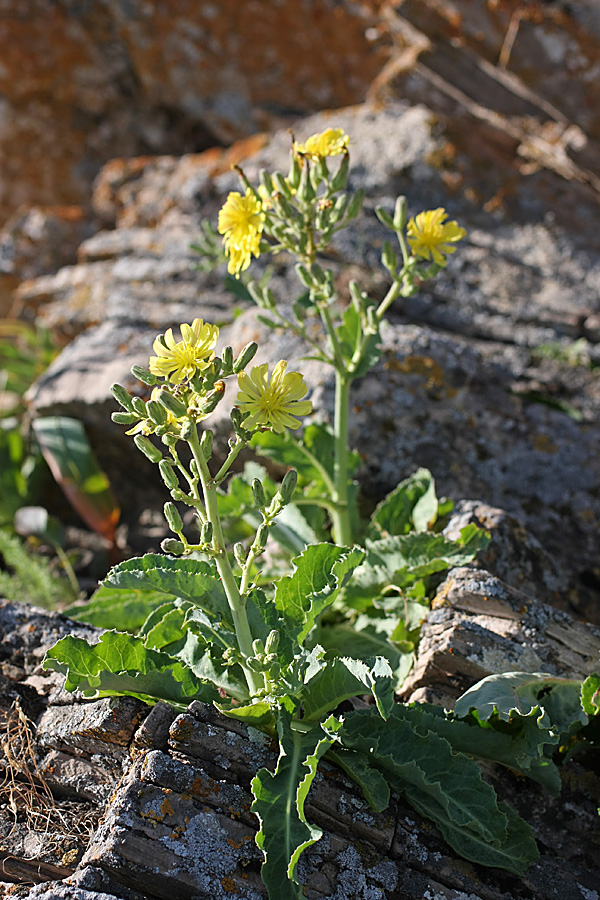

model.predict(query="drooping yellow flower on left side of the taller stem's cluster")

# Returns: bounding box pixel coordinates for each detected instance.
[219,188,265,275]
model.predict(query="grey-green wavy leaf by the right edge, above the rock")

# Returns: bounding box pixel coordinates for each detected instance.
[454,672,588,736]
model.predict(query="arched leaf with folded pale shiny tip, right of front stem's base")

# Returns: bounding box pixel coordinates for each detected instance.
[302,656,394,721]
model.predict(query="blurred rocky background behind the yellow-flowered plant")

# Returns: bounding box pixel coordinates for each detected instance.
[0,0,600,621]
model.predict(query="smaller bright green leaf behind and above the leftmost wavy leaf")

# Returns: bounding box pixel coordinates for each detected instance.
[65,587,169,634]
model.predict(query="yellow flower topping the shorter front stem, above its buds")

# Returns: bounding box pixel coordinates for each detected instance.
[148,319,219,384]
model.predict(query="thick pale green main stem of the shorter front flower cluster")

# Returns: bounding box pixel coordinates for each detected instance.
[188,431,262,696]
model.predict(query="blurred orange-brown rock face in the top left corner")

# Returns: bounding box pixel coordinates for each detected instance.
[0,0,385,222]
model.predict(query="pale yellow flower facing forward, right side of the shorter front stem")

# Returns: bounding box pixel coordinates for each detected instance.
[236,359,312,434]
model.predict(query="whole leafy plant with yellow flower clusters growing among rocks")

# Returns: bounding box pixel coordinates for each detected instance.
[45,128,564,900]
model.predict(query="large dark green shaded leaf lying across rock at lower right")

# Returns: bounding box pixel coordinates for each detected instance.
[340,707,537,874]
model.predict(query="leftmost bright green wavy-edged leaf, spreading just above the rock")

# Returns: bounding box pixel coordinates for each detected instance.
[43,631,219,708]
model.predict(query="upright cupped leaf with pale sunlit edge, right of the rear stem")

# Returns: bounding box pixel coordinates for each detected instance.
[369,469,438,539]
